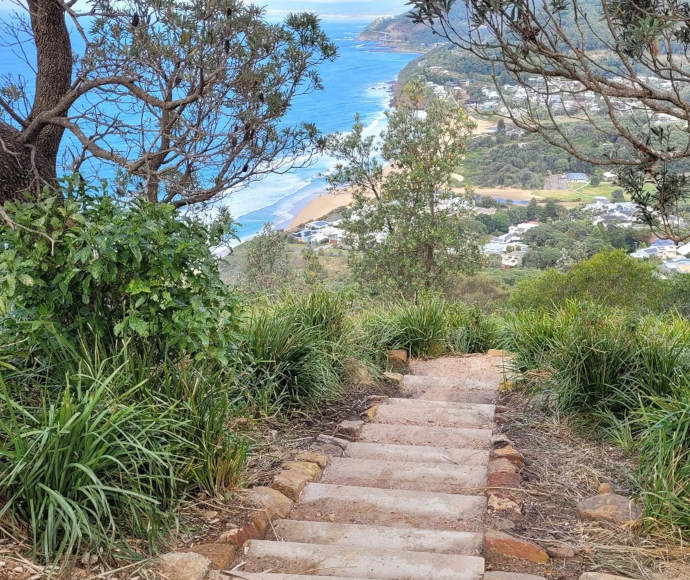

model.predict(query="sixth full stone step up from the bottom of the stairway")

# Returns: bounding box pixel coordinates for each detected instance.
[359,422,492,449]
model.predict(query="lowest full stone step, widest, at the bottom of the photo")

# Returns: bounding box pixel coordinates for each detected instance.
[245,540,484,580]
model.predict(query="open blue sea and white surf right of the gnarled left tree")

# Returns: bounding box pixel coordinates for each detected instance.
[226,20,416,239]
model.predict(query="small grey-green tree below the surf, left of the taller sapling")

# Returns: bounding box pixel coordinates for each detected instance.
[244,223,291,293]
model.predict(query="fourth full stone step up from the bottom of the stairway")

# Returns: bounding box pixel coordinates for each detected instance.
[320,451,489,493]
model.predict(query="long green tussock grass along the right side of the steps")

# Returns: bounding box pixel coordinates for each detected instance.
[501,301,690,536]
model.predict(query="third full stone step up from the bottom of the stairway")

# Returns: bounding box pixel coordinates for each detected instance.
[290,483,486,531]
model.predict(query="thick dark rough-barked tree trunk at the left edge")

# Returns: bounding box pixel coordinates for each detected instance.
[0,0,72,203]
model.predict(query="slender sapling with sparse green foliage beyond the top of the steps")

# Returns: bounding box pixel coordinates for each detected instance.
[328,84,479,295]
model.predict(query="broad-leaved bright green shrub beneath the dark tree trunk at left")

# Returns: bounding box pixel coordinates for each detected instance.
[0,190,235,359]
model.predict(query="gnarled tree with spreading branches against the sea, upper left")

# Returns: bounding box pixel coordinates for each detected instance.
[0,0,336,207]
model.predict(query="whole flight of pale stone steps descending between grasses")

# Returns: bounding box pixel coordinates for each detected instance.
[231,355,537,580]
